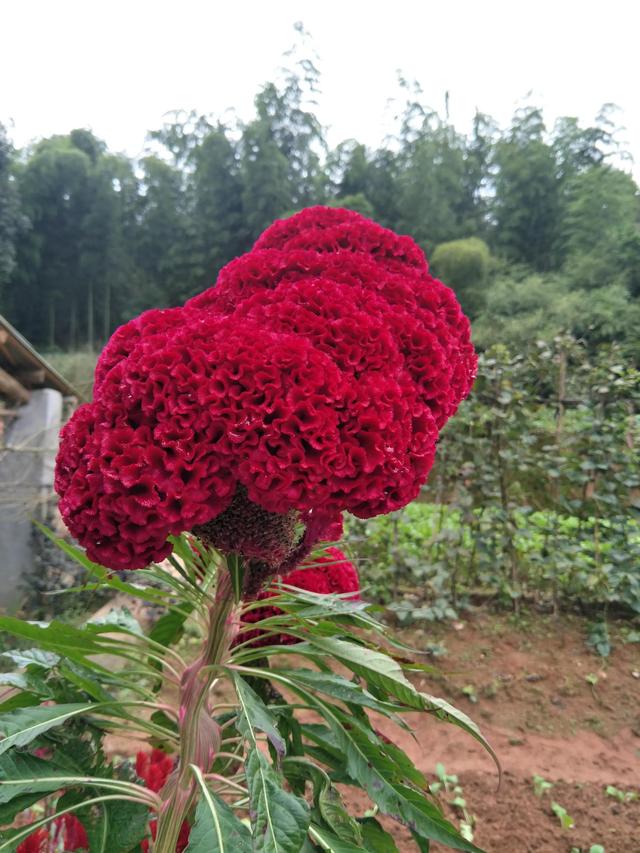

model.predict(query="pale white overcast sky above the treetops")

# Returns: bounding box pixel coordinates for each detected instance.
[0,0,640,177]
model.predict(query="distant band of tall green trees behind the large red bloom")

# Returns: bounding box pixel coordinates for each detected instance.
[0,55,640,358]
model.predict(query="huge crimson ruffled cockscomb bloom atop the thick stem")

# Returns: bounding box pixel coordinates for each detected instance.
[56,208,476,570]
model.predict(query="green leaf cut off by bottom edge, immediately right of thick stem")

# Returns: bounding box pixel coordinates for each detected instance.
[186,765,252,853]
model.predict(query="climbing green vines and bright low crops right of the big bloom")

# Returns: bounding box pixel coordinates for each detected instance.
[348,338,640,620]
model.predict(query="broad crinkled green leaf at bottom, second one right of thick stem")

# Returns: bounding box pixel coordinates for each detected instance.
[245,747,310,853]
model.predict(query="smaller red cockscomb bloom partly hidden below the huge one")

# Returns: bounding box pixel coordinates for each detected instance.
[238,548,360,647]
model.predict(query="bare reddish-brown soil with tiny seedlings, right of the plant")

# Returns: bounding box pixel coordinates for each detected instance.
[370,612,640,853]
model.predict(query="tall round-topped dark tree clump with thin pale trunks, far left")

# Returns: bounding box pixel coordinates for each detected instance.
[10,129,142,348]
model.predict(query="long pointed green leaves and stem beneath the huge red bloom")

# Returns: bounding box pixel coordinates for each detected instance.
[0,536,490,853]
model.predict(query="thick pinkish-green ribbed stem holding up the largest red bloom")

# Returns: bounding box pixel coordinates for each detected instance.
[153,556,238,853]
